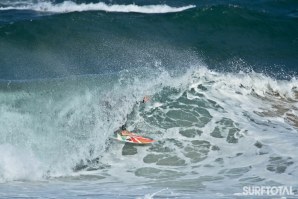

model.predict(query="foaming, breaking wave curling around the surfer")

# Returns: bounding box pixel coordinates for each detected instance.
[0,67,298,188]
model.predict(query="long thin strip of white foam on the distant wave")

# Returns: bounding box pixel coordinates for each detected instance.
[0,1,195,14]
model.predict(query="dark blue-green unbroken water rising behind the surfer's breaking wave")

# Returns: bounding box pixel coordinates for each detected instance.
[0,1,298,79]
